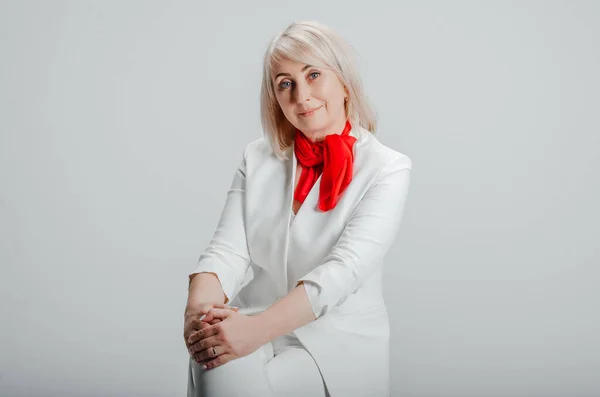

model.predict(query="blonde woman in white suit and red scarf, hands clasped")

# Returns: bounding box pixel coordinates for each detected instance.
[184,22,411,397]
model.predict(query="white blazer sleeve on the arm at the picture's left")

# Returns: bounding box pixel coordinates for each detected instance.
[188,146,250,302]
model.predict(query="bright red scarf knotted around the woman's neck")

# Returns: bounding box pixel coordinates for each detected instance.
[294,120,356,211]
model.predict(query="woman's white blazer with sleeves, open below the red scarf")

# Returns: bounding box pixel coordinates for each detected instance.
[192,127,411,397]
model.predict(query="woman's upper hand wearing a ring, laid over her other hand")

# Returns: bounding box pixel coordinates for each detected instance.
[188,309,268,369]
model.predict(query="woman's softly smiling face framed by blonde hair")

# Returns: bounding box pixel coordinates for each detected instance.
[271,60,348,140]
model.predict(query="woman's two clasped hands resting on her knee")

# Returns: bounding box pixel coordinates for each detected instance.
[183,303,267,369]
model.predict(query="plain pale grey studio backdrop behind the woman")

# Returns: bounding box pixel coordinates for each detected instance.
[0,0,600,397]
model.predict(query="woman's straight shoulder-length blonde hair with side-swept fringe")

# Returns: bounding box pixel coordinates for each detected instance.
[260,21,377,159]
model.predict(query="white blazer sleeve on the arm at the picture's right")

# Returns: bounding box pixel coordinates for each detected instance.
[298,155,412,318]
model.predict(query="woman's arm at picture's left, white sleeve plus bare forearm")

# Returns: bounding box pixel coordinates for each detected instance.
[188,147,250,305]
